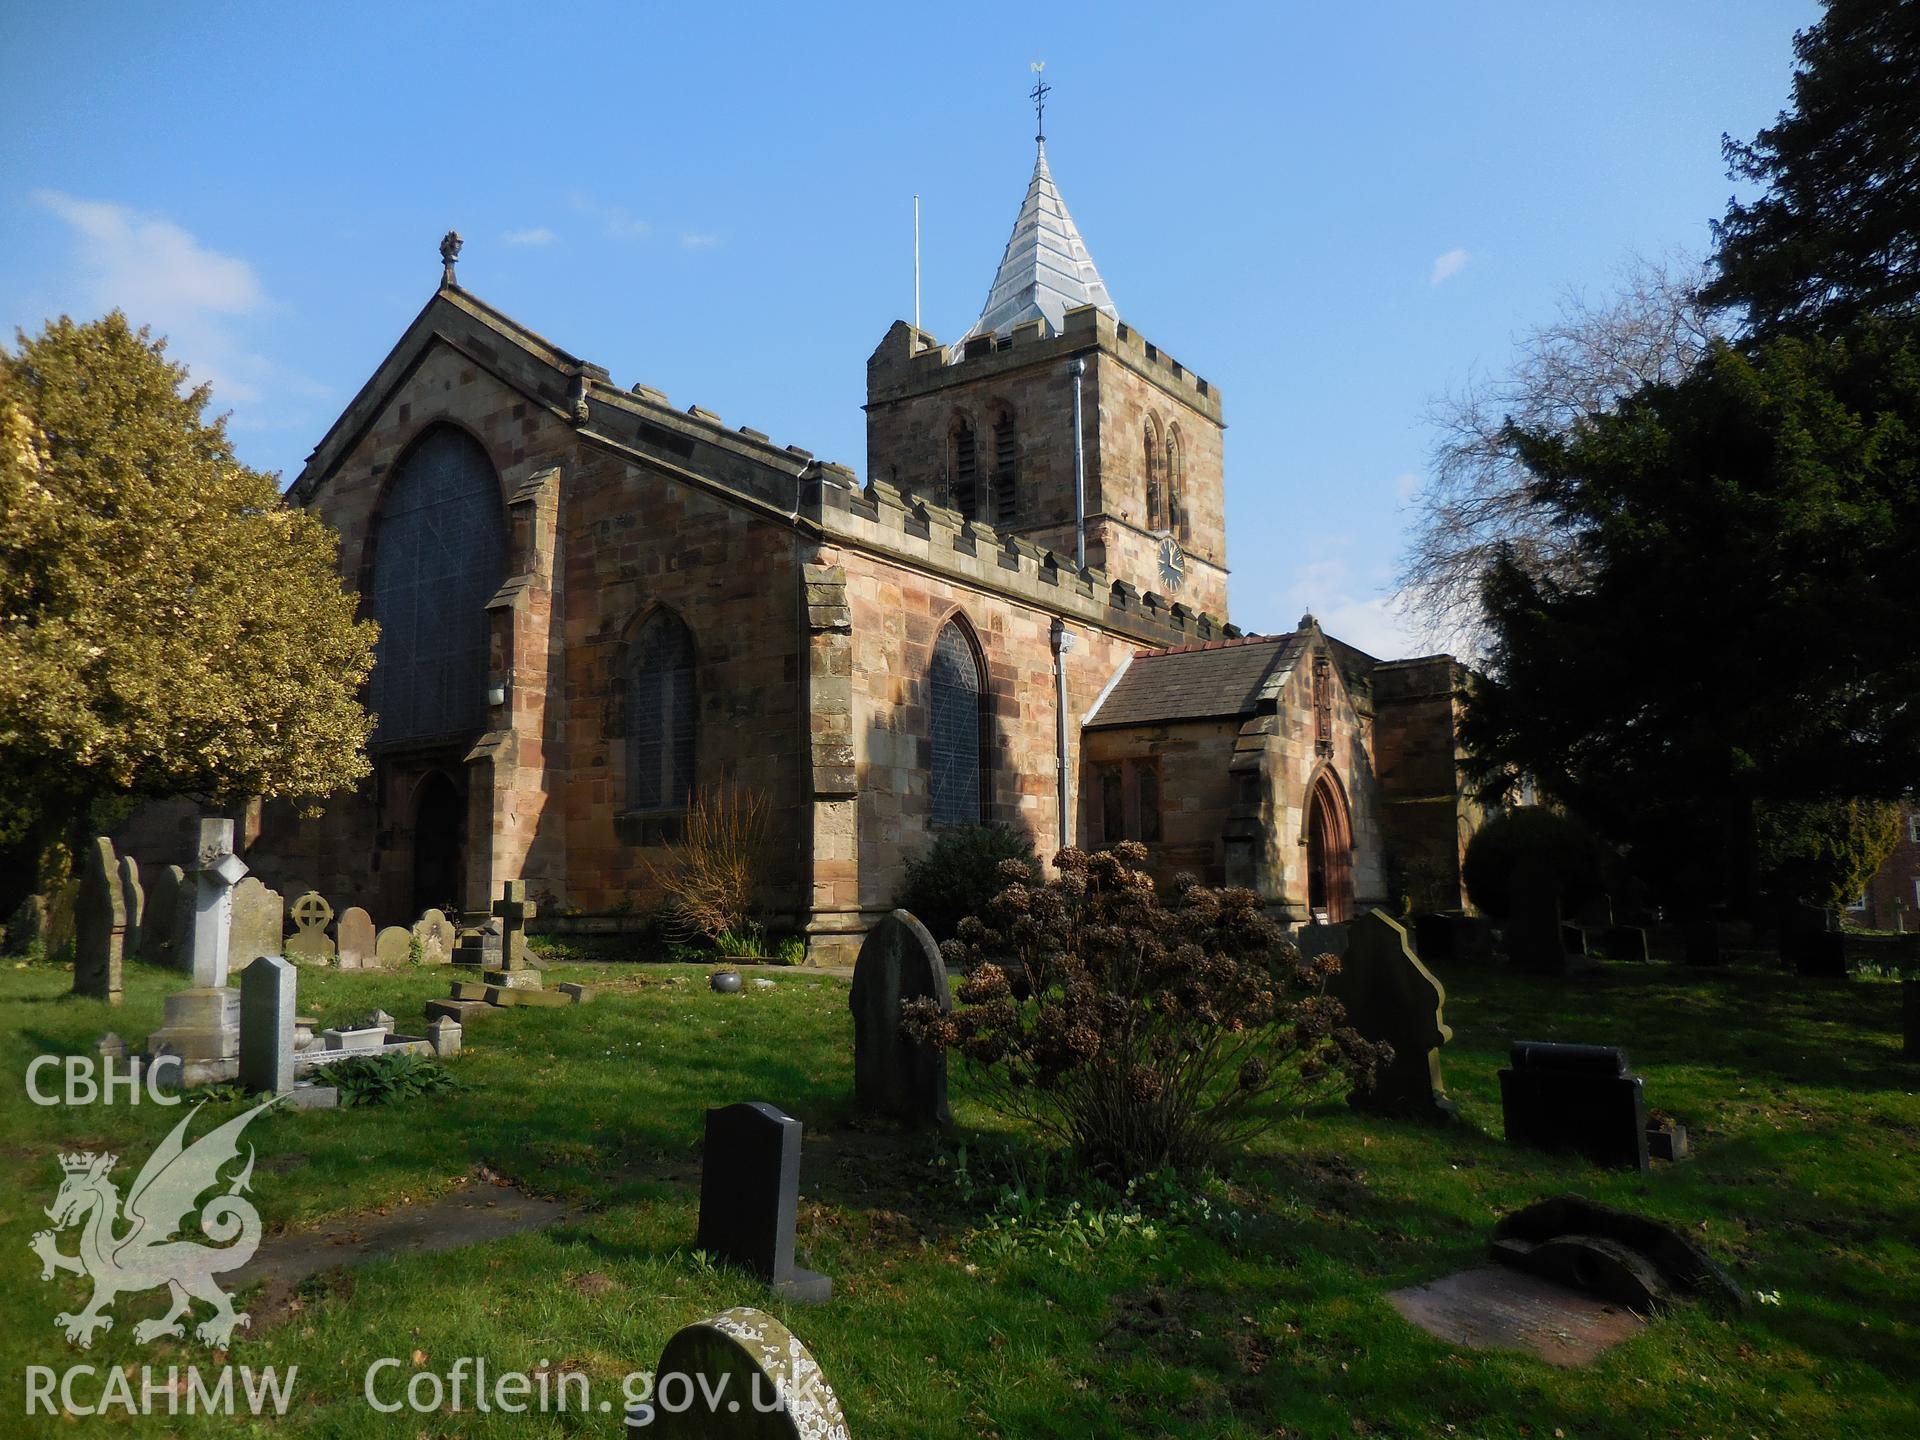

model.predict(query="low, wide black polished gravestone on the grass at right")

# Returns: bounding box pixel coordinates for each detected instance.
[1500,1041,1647,1169]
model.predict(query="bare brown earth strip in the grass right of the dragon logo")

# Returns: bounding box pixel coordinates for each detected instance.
[225,1181,572,1331]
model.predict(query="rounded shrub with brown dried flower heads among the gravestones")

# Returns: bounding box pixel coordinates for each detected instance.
[904,841,1388,1185]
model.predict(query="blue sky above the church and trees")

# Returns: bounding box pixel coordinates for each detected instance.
[0,0,1818,653]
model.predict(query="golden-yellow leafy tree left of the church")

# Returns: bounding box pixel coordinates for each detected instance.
[0,311,374,914]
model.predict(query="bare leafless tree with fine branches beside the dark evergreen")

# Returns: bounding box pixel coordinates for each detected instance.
[1400,253,1724,657]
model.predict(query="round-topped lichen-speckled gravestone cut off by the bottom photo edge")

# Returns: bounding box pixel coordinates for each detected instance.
[626,1306,849,1440]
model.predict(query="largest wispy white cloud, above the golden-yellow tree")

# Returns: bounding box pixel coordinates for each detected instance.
[33,190,328,430]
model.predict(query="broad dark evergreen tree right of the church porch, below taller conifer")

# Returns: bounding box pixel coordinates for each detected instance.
[1463,321,1920,900]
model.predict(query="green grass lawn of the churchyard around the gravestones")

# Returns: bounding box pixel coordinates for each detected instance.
[0,964,1920,1440]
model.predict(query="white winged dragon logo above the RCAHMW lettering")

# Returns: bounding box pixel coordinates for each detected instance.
[29,1100,275,1350]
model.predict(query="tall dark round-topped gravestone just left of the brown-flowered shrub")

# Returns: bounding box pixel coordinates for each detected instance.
[849,910,954,1125]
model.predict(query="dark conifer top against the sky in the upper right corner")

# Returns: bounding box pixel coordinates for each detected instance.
[1703,0,1920,334]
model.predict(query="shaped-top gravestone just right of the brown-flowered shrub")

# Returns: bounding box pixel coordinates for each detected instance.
[1327,910,1457,1119]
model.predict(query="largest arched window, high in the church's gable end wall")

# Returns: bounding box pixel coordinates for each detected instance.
[367,424,507,741]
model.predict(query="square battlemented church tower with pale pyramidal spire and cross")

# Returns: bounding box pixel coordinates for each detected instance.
[866,102,1227,620]
